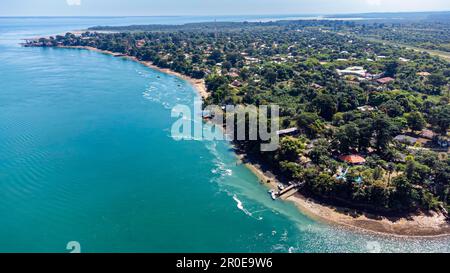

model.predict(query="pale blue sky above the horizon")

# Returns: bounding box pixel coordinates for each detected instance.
[0,0,450,16]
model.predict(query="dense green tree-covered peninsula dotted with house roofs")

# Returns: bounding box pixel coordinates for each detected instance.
[27,20,450,214]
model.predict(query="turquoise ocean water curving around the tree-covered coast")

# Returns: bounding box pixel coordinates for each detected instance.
[0,17,450,252]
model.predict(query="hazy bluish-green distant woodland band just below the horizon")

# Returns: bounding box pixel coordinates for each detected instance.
[90,12,450,54]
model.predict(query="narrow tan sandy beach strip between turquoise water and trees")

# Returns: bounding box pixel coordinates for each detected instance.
[57,46,450,238]
